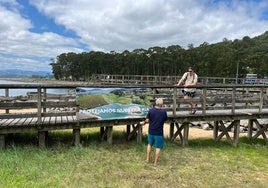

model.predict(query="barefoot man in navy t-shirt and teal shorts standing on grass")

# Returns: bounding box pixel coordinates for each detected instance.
[141,98,167,166]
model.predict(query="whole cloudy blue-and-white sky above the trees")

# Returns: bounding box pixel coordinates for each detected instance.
[0,0,268,71]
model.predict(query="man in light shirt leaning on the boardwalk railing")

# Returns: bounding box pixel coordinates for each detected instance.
[176,67,198,114]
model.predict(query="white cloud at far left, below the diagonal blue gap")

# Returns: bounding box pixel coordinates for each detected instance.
[0,1,85,70]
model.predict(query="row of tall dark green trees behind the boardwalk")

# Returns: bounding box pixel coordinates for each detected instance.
[50,31,268,81]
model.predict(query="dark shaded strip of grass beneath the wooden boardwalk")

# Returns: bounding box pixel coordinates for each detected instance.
[3,129,267,148]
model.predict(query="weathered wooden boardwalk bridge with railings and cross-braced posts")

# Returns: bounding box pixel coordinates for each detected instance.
[0,84,268,148]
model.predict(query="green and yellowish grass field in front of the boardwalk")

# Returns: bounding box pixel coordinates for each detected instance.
[0,128,268,188]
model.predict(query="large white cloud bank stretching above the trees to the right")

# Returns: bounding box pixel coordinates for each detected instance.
[32,0,268,51]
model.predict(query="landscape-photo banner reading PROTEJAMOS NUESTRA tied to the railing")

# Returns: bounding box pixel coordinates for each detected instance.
[76,87,152,120]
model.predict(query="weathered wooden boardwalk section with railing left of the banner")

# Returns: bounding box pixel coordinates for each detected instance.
[0,84,77,147]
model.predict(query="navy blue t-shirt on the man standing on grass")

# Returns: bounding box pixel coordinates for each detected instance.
[146,108,167,136]
